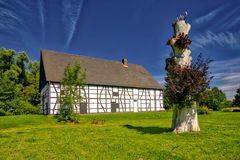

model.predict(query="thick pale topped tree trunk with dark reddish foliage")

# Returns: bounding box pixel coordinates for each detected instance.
[165,15,212,133]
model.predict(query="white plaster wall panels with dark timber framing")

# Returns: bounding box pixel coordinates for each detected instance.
[45,83,164,114]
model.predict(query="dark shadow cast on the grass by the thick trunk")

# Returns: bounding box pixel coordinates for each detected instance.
[123,124,172,134]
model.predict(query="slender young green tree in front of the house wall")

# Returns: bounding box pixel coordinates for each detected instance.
[57,62,86,122]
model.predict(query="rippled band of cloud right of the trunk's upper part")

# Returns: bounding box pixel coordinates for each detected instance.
[192,31,240,50]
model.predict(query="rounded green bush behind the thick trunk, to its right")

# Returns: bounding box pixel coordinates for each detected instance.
[200,87,228,111]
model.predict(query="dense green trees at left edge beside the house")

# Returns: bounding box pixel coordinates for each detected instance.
[0,48,40,115]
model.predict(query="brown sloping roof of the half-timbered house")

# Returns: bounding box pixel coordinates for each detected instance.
[41,50,162,89]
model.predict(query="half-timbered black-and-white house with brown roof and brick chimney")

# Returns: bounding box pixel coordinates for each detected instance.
[40,50,164,114]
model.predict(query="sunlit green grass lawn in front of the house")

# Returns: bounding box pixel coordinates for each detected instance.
[0,112,240,160]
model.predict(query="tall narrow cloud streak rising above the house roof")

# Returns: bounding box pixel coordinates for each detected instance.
[62,0,84,48]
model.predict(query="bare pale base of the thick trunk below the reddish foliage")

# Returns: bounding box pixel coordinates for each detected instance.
[172,102,200,133]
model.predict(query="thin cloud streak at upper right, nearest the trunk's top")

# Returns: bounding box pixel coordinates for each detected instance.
[193,6,226,24]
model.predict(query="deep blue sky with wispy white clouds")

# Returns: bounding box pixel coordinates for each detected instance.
[0,0,240,99]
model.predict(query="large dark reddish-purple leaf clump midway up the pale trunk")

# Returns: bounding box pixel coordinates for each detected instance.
[165,54,213,108]
